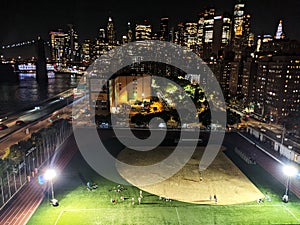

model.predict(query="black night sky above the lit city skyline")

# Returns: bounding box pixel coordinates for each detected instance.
[0,0,300,45]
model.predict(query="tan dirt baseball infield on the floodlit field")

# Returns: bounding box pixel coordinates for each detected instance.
[116,147,264,205]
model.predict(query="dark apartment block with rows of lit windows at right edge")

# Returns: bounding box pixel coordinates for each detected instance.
[255,55,300,120]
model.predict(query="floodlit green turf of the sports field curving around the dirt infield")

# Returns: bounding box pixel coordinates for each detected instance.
[28,149,300,225]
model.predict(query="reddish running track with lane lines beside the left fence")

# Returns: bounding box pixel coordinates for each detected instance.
[0,135,77,225]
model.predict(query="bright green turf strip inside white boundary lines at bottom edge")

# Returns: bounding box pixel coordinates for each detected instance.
[51,206,295,225]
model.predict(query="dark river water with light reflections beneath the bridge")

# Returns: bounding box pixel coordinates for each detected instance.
[0,74,80,116]
